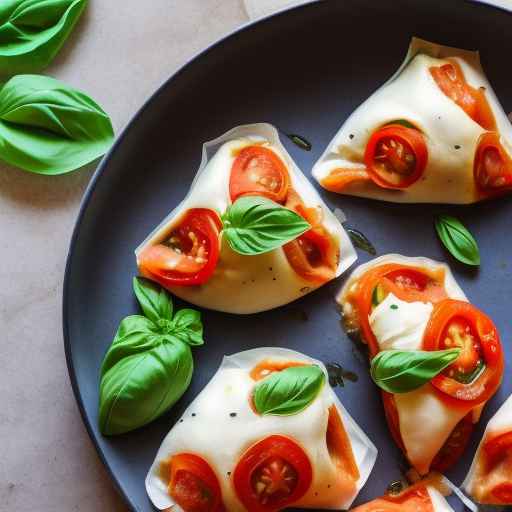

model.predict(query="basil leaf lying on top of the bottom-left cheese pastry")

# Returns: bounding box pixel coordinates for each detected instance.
[253,365,325,416]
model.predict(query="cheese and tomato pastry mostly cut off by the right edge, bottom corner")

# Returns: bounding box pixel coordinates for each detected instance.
[462,396,512,505]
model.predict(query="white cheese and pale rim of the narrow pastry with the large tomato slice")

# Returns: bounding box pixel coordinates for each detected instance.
[338,254,471,474]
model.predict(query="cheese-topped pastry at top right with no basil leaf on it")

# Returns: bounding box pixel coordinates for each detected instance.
[313,38,512,204]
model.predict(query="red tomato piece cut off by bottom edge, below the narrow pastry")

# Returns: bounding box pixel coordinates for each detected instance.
[351,483,435,512]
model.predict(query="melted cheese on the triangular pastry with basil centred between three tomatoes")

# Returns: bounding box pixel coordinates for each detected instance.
[135,124,357,314]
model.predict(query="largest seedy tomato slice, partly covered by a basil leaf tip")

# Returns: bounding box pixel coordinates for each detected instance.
[423,299,504,407]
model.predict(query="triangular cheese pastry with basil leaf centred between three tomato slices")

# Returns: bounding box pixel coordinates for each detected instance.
[136,124,356,313]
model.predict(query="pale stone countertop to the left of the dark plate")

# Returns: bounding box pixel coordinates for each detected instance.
[0,0,247,512]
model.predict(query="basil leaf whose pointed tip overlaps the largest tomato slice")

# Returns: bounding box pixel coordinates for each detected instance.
[371,348,460,393]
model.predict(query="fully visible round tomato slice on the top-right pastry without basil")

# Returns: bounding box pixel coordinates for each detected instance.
[364,124,428,189]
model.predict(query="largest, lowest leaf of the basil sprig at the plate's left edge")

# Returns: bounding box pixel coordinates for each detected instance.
[99,338,193,435]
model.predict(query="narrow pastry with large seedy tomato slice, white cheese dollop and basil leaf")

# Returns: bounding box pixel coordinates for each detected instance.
[338,254,503,475]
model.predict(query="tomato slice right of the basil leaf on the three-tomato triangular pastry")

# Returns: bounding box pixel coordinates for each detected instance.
[283,189,339,283]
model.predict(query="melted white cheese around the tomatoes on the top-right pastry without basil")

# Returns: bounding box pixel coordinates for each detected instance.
[313,38,512,204]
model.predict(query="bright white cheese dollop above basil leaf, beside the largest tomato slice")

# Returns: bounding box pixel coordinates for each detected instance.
[370,293,434,350]
